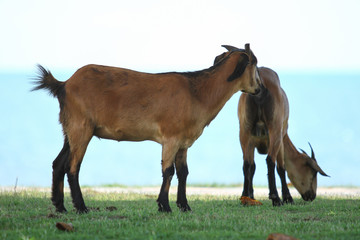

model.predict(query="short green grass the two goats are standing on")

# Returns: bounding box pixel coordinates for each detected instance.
[0,190,360,240]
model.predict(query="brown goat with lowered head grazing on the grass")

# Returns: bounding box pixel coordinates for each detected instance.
[214,45,327,206]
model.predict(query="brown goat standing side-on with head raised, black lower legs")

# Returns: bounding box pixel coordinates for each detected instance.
[33,44,260,213]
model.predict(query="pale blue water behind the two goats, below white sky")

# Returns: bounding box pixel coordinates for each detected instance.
[0,71,360,186]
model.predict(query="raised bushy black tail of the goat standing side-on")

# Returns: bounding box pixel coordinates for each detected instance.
[31,64,65,98]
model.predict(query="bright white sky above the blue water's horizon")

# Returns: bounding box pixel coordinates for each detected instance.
[0,0,360,71]
